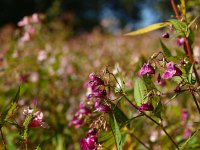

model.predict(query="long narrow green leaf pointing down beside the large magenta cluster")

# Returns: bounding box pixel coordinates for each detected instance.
[109,113,122,150]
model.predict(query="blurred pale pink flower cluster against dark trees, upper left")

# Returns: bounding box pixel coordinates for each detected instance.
[17,13,41,42]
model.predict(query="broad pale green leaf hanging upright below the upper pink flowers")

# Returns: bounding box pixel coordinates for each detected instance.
[134,78,147,106]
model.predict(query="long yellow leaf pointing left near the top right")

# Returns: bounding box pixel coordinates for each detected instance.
[125,22,170,36]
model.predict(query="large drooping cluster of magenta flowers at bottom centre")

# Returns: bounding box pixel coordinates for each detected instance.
[69,73,111,150]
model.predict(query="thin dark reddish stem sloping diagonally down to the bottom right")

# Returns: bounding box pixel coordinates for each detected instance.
[123,93,179,150]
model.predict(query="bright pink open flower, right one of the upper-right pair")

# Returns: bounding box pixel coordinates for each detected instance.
[162,61,182,79]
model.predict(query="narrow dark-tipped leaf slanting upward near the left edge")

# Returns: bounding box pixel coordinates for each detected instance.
[3,87,20,122]
